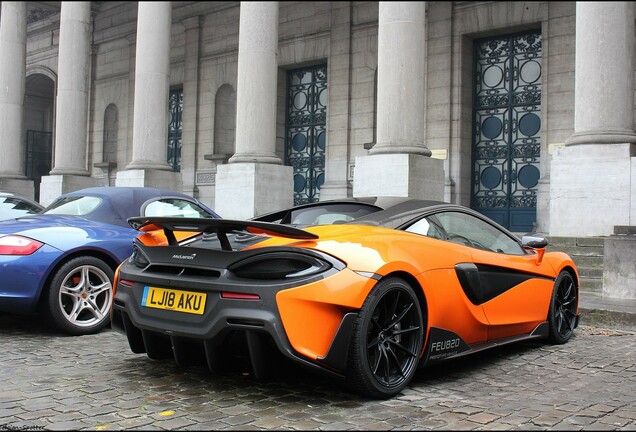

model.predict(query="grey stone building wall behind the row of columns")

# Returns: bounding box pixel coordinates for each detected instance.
[27,1,575,223]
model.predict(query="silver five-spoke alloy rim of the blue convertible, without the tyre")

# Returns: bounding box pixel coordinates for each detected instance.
[58,265,113,327]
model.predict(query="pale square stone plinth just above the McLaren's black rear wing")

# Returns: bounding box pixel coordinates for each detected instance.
[214,163,294,219]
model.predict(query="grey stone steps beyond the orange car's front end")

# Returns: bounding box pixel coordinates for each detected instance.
[547,236,605,297]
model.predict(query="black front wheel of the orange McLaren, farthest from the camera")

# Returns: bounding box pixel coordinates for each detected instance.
[548,270,578,344]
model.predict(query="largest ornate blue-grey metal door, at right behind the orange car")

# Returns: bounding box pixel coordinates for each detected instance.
[471,31,541,232]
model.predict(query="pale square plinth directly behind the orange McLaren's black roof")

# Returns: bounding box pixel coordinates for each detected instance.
[353,153,445,201]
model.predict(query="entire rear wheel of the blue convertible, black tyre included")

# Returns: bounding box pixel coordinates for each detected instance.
[44,257,114,336]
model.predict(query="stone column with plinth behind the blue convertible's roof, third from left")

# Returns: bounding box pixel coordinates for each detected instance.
[116,1,181,189]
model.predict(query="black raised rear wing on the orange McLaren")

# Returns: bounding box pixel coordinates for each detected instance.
[128,216,318,250]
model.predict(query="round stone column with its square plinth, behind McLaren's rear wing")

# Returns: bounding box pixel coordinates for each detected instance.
[215,1,293,219]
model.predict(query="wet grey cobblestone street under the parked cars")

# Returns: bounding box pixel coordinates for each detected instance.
[0,314,636,430]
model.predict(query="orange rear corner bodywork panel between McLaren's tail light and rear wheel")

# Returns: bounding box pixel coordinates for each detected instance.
[276,269,376,360]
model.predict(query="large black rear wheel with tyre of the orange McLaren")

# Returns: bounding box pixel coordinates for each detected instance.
[347,277,424,399]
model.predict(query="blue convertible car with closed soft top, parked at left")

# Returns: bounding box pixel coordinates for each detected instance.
[0,187,219,335]
